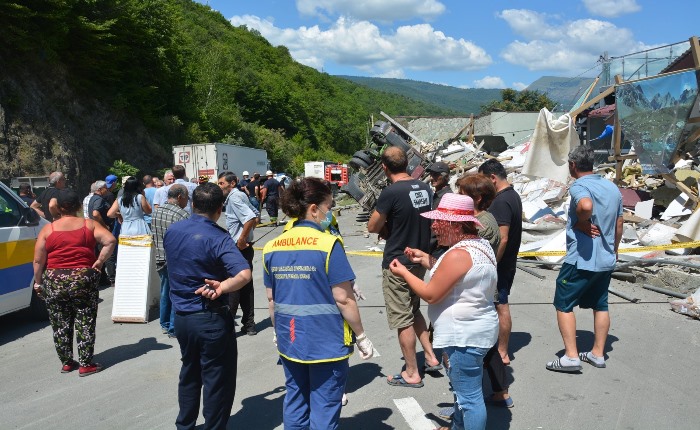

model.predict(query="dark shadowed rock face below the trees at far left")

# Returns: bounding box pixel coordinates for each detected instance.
[0,57,172,193]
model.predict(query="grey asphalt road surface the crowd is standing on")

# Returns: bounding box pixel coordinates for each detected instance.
[0,207,700,430]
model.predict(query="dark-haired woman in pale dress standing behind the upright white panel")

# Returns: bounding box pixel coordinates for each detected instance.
[107,176,151,236]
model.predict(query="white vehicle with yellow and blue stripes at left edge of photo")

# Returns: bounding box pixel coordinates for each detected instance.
[0,182,47,318]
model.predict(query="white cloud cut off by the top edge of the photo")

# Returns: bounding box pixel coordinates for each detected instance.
[297,0,446,22]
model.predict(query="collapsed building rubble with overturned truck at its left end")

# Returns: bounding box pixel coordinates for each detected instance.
[345,37,700,318]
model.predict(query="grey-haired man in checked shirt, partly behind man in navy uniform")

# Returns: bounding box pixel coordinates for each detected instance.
[151,184,190,337]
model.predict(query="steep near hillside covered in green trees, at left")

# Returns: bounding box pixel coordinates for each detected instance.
[0,0,451,191]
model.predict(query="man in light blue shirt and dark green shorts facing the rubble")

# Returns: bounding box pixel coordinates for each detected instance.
[547,146,623,372]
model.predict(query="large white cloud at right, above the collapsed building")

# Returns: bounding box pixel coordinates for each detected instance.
[498,10,647,73]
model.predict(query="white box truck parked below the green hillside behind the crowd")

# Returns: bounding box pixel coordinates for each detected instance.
[173,143,268,182]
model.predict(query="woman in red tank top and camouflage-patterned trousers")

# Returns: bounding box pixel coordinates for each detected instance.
[34,189,116,376]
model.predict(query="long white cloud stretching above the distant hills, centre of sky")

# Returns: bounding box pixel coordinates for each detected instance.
[231,15,492,76]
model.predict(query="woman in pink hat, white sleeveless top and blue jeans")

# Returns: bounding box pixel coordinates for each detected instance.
[389,194,498,430]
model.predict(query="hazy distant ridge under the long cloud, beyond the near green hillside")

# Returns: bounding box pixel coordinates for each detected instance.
[339,76,501,115]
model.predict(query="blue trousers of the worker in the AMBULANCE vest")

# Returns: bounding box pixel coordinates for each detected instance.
[282,358,349,430]
